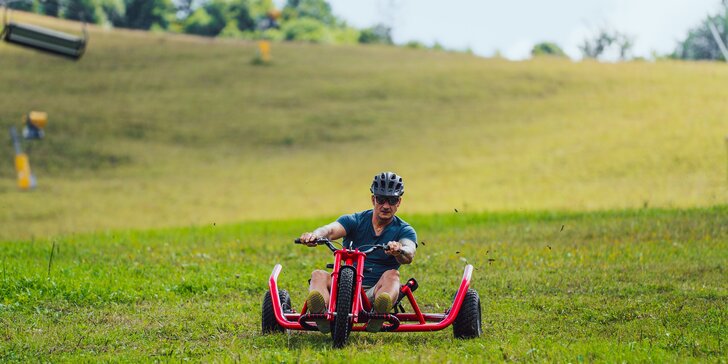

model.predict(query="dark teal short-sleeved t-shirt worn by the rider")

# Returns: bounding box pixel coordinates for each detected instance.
[336,210,417,286]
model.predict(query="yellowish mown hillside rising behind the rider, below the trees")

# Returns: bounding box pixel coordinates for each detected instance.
[0,13,728,239]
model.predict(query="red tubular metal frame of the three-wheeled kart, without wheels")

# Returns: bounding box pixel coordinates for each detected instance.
[268,253,473,332]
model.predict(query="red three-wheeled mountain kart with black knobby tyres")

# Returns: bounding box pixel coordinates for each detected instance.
[262,239,482,348]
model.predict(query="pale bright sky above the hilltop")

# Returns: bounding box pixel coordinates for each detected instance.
[322,0,721,60]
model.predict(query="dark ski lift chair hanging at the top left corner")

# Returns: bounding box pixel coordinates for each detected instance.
[0,1,88,60]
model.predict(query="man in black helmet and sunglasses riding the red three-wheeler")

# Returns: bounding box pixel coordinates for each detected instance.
[301,172,417,333]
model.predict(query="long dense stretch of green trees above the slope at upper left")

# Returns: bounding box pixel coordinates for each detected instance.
[5,0,393,44]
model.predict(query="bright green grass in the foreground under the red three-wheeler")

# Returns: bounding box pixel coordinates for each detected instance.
[0,206,728,362]
